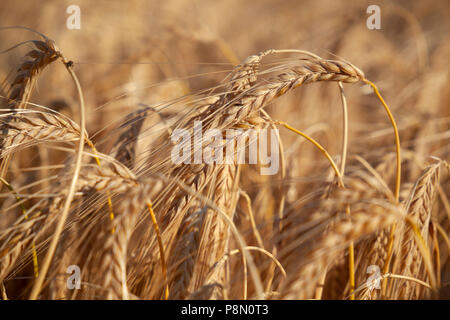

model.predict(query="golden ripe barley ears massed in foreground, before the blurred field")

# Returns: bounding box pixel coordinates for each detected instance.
[0,30,450,299]
